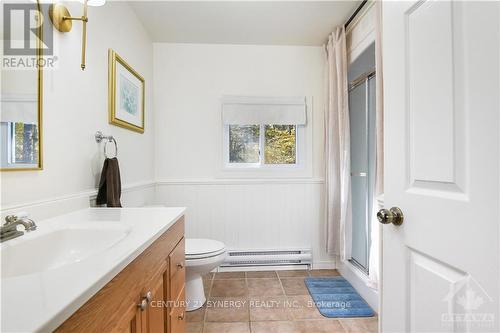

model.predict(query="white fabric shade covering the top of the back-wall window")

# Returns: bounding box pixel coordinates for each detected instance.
[222,96,307,125]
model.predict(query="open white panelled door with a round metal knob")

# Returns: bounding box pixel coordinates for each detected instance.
[381,1,500,332]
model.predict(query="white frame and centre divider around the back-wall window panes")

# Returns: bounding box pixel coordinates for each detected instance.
[222,124,306,170]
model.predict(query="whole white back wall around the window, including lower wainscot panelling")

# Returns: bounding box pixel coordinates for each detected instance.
[154,43,334,267]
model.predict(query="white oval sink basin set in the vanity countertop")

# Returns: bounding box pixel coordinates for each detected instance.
[1,227,130,278]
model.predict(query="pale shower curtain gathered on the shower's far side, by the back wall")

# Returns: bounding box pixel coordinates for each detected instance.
[325,26,351,261]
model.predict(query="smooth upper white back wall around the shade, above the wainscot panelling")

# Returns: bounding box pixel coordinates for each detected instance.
[154,43,323,180]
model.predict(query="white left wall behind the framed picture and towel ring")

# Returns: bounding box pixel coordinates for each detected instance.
[1,1,154,215]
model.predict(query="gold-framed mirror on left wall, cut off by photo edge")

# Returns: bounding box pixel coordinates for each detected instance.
[0,4,43,171]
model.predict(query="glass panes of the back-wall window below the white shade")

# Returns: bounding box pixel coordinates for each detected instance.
[226,125,297,167]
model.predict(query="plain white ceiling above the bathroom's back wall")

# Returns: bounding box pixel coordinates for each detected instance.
[129,1,361,46]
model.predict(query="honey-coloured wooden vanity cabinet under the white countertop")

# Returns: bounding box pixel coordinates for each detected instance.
[56,217,185,333]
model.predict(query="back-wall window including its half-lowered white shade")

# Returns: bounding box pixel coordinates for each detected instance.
[222,96,306,169]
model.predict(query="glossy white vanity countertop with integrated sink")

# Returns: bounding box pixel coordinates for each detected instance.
[0,207,185,332]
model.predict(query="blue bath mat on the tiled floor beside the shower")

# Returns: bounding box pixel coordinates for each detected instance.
[305,276,374,318]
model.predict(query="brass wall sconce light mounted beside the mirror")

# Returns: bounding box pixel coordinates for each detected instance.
[49,0,106,71]
